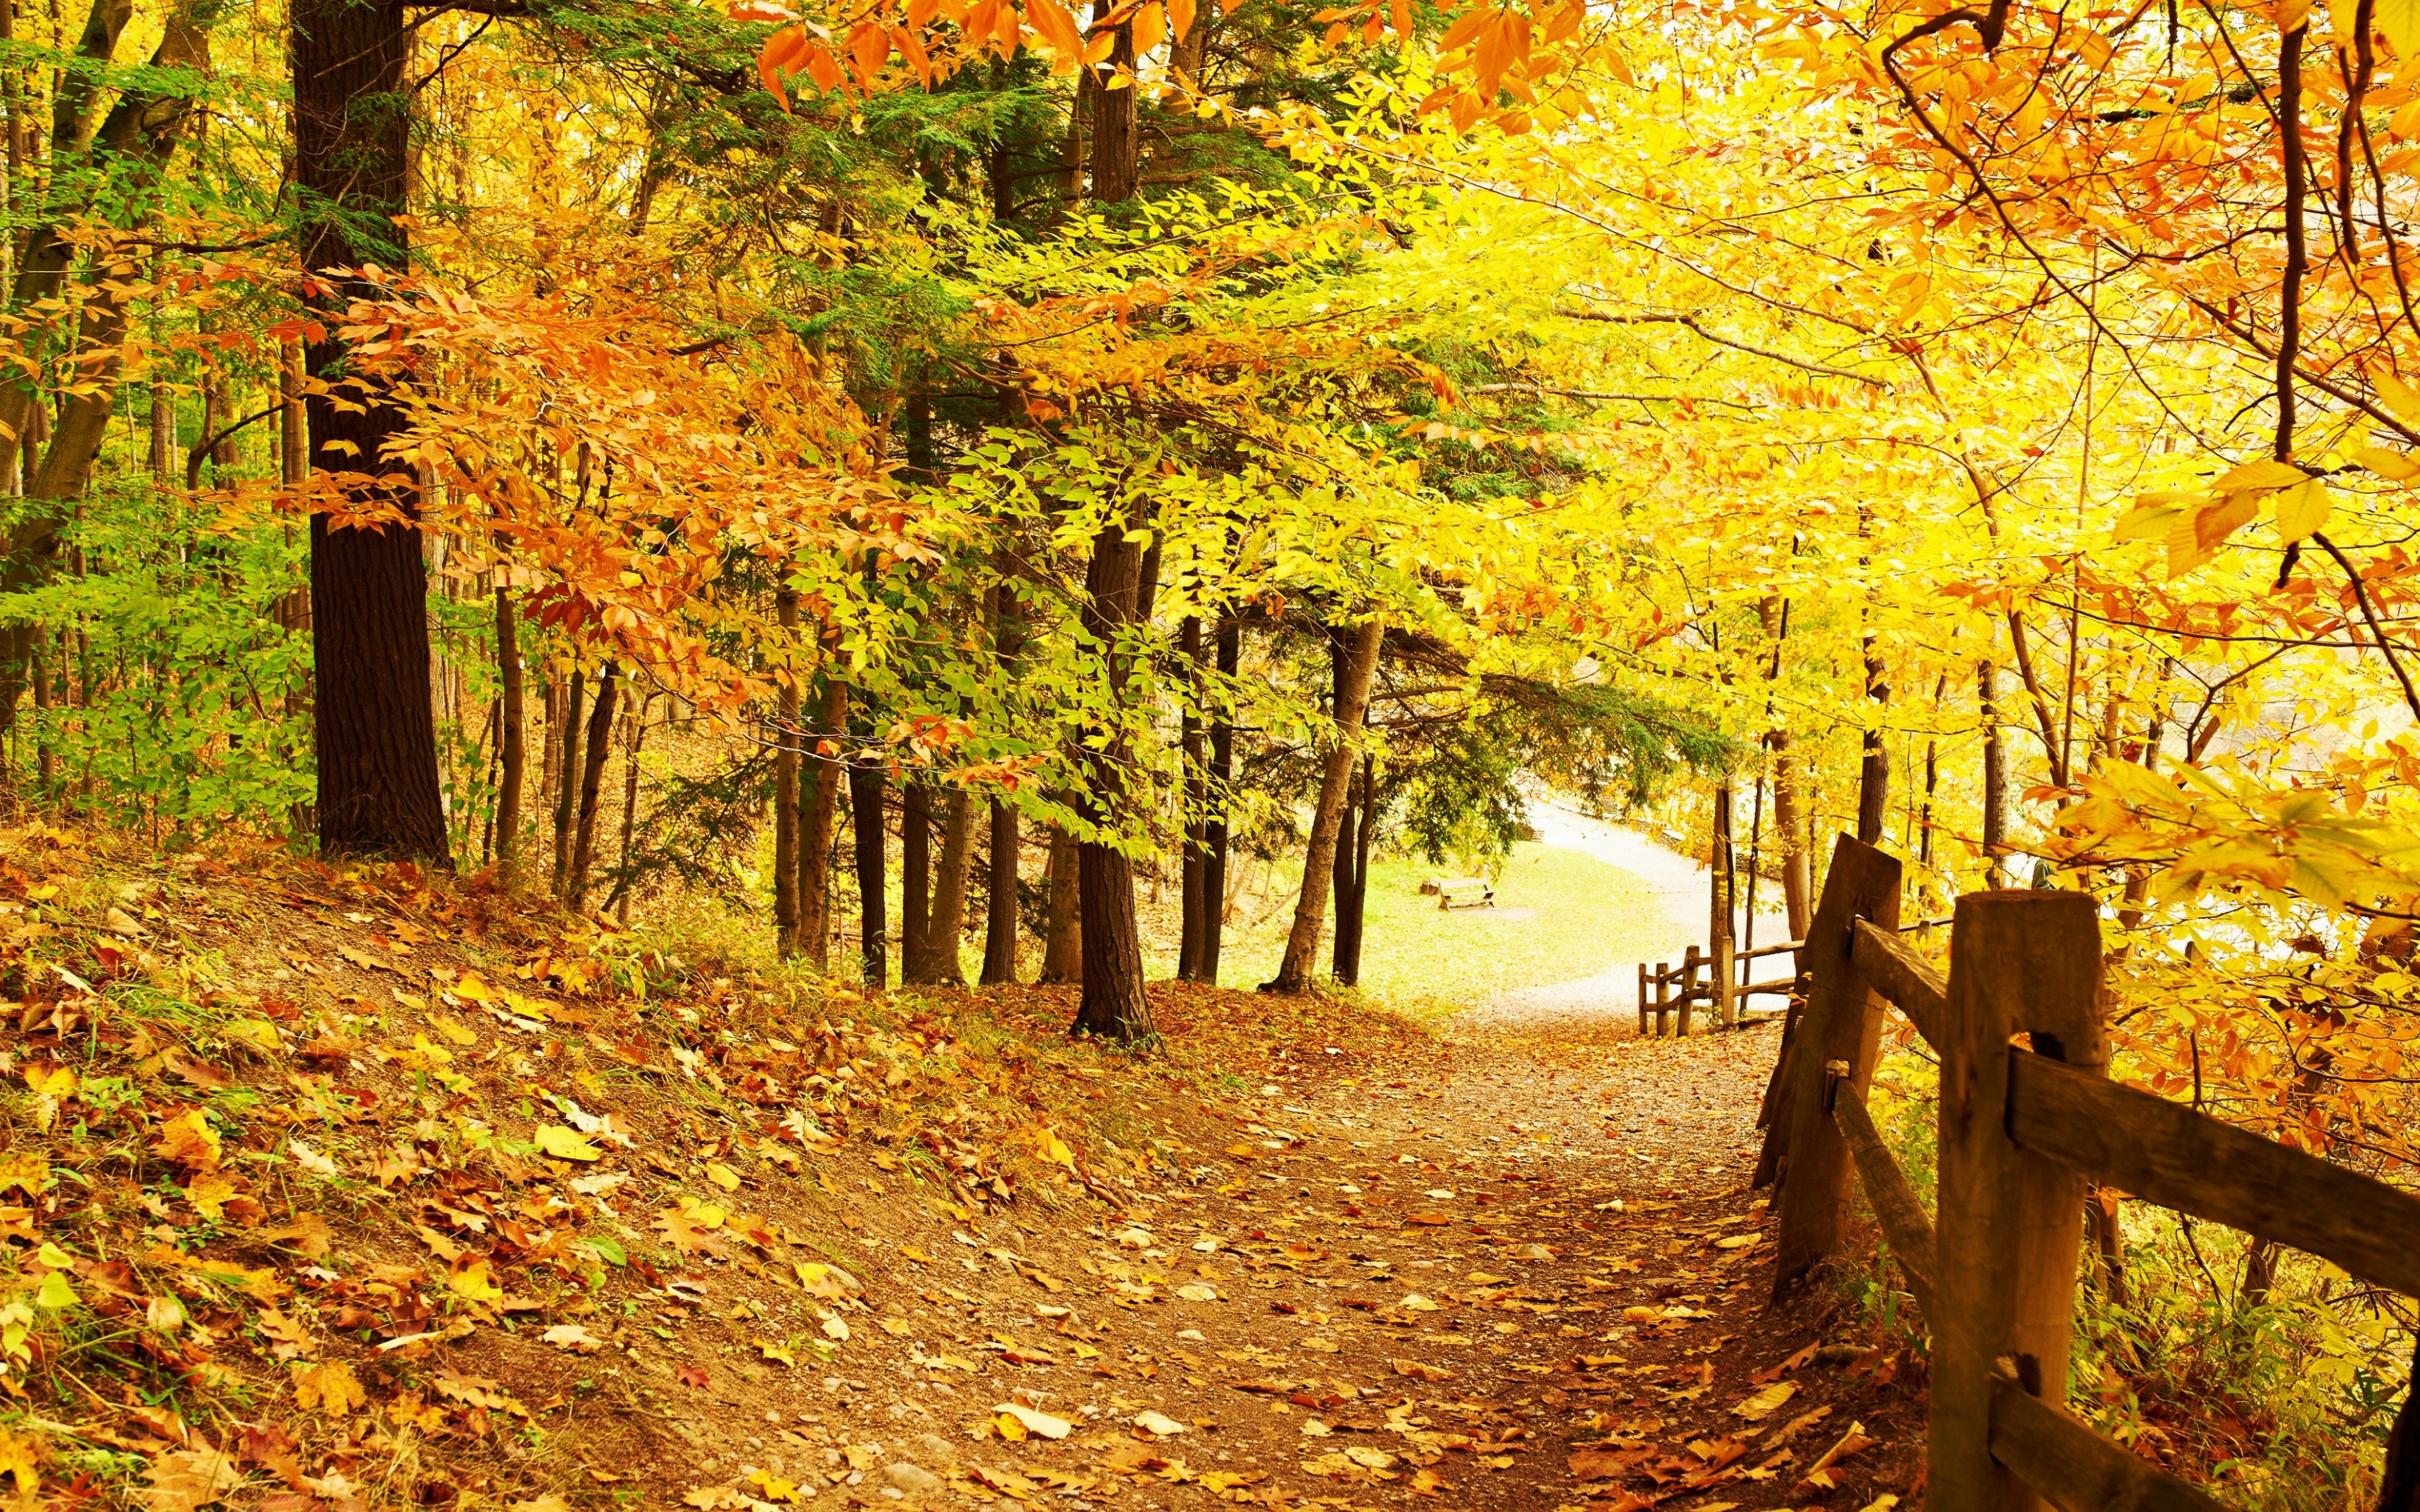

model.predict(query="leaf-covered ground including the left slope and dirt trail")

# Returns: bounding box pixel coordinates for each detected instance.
[0,830,1922,1512]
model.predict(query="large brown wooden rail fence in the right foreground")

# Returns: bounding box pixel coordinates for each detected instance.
[1760,835,2420,1512]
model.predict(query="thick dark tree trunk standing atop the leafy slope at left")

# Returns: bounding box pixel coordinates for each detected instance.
[291,0,448,866]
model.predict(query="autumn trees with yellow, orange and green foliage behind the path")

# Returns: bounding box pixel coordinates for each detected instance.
[0,0,2420,1485]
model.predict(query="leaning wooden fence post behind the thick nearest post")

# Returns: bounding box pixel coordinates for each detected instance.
[1769,835,1897,1287]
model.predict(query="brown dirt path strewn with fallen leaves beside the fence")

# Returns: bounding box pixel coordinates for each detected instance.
[609,987,1912,1512]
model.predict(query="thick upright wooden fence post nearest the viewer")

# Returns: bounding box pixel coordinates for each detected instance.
[1926,890,2107,1512]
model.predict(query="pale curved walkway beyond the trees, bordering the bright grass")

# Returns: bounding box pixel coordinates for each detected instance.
[1462,798,1791,1031]
